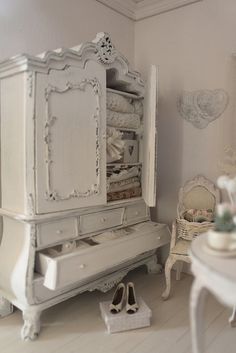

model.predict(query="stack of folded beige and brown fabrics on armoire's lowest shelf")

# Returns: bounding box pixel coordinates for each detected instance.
[107,167,142,201]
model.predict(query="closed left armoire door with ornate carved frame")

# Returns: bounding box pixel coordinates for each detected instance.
[35,61,106,213]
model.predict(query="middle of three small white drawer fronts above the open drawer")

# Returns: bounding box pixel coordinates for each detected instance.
[80,208,124,234]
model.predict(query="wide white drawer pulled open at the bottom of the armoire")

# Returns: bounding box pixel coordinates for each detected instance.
[35,221,170,290]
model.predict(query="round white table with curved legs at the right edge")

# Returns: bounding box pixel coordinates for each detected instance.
[190,234,236,353]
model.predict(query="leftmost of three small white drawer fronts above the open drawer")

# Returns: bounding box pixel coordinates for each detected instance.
[37,217,78,247]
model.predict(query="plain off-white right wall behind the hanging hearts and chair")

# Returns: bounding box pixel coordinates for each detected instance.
[135,0,236,223]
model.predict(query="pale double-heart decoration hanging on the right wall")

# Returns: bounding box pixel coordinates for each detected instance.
[177,89,229,129]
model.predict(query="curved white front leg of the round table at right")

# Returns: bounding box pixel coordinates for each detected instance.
[190,278,207,353]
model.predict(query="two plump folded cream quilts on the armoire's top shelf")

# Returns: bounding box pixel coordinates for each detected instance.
[107,91,143,129]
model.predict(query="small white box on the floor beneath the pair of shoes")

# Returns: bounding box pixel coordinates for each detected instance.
[100,298,152,333]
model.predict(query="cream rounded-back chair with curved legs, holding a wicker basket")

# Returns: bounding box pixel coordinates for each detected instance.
[162,175,220,300]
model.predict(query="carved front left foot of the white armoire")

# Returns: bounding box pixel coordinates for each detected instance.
[21,309,41,341]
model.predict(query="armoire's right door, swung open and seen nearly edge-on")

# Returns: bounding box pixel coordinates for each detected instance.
[142,65,157,207]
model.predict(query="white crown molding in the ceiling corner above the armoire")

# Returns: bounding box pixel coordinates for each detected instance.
[96,0,203,21]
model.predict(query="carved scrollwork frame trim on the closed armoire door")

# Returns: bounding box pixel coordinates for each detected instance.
[44,78,101,201]
